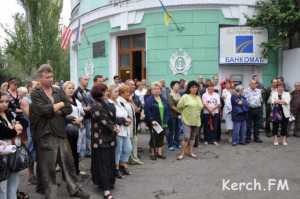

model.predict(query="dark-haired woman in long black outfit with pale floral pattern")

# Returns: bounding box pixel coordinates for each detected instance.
[91,83,117,199]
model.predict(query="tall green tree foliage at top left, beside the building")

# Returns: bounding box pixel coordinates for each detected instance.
[1,0,69,80]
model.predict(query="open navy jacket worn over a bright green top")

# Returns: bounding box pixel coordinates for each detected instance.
[145,96,170,127]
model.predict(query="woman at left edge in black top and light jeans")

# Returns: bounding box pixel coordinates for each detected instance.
[0,92,26,199]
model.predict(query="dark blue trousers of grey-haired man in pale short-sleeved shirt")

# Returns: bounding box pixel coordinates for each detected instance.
[246,107,262,141]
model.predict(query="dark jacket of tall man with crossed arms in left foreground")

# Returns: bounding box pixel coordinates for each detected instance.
[30,87,72,142]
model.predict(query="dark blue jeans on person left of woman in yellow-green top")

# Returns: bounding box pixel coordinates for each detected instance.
[166,117,180,148]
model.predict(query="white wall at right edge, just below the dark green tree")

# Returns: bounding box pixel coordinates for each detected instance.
[282,48,300,88]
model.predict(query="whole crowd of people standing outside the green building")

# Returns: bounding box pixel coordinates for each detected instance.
[0,64,300,199]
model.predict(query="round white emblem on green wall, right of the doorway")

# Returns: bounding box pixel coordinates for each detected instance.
[170,49,192,75]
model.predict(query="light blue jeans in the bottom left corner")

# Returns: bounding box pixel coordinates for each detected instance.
[0,173,20,199]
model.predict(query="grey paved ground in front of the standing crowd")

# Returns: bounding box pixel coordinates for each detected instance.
[21,132,300,199]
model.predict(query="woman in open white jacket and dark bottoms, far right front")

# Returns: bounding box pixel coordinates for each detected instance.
[271,83,291,146]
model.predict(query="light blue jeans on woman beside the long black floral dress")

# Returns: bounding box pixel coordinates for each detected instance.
[116,136,132,164]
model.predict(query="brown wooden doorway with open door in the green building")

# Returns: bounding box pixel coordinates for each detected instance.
[118,33,146,81]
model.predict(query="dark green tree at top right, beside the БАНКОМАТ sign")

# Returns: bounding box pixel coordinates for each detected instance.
[247,0,300,54]
